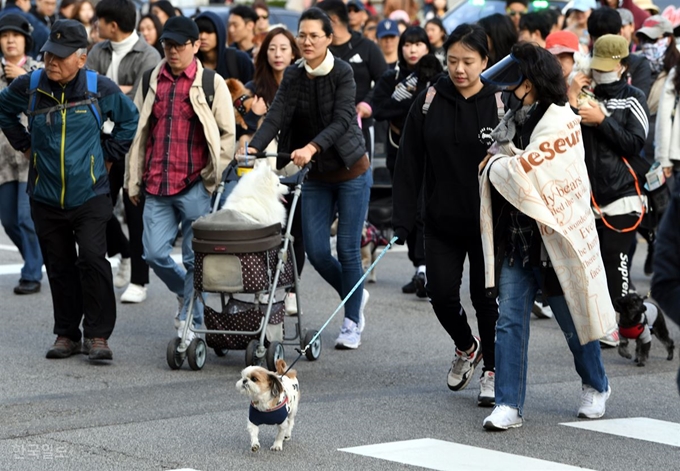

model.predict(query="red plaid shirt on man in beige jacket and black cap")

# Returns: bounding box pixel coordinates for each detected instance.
[144,59,209,196]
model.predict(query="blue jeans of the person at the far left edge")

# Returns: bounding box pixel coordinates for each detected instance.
[0,181,43,281]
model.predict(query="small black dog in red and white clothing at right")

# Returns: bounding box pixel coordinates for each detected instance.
[614,293,675,366]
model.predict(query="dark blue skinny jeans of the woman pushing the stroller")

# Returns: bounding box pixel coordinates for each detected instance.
[301,170,373,323]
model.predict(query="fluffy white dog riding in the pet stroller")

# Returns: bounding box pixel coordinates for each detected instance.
[220,162,290,227]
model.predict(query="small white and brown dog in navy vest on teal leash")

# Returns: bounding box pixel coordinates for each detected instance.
[236,359,300,451]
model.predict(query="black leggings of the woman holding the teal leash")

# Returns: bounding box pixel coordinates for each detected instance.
[425,228,498,371]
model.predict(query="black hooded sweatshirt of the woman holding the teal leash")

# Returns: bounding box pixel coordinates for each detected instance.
[392,75,499,238]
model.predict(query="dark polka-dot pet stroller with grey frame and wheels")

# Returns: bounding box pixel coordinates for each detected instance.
[166,153,321,371]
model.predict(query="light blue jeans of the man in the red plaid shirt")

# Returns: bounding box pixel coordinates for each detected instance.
[142,181,210,326]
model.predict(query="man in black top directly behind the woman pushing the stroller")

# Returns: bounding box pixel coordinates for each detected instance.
[318,0,387,158]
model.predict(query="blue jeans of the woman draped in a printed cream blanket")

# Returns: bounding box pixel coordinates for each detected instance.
[496,257,609,415]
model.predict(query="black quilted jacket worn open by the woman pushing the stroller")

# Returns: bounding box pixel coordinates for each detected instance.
[249,58,366,172]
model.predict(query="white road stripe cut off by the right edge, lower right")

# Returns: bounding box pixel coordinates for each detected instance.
[560,417,680,447]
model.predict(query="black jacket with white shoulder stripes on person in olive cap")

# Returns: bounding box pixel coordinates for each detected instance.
[581,80,649,206]
